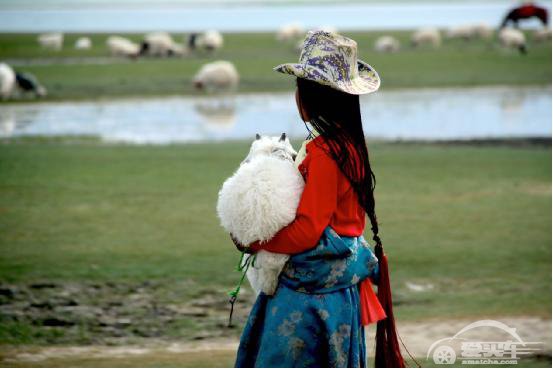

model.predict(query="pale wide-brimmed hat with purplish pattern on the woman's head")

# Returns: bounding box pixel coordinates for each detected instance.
[273,31,380,95]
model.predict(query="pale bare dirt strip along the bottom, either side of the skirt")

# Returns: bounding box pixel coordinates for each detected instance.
[0,317,551,366]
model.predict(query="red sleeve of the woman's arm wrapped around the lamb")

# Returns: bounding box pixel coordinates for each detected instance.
[250,153,338,254]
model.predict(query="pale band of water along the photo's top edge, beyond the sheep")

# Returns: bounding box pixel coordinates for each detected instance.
[0,0,551,32]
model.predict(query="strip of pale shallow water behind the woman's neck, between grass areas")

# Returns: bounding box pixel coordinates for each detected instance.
[0,87,551,144]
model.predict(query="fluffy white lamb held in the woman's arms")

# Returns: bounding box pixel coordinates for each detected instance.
[217,133,304,295]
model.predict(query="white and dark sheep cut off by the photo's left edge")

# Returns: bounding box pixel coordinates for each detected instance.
[0,63,46,100]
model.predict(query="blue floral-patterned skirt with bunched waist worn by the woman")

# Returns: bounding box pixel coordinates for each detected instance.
[235,227,378,367]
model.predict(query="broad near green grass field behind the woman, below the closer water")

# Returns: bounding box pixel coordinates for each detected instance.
[0,141,551,319]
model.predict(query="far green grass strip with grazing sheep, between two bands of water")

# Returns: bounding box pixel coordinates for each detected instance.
[0,31,551,100]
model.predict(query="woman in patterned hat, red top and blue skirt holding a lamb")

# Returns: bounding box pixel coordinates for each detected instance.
[236,31,403,367]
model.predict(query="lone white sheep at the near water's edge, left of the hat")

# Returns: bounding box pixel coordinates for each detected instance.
[192,60,240,93]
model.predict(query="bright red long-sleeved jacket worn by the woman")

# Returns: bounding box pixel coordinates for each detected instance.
[250,136,365,254]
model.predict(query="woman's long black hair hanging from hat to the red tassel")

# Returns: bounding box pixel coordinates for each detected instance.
[296,78,381,246]
